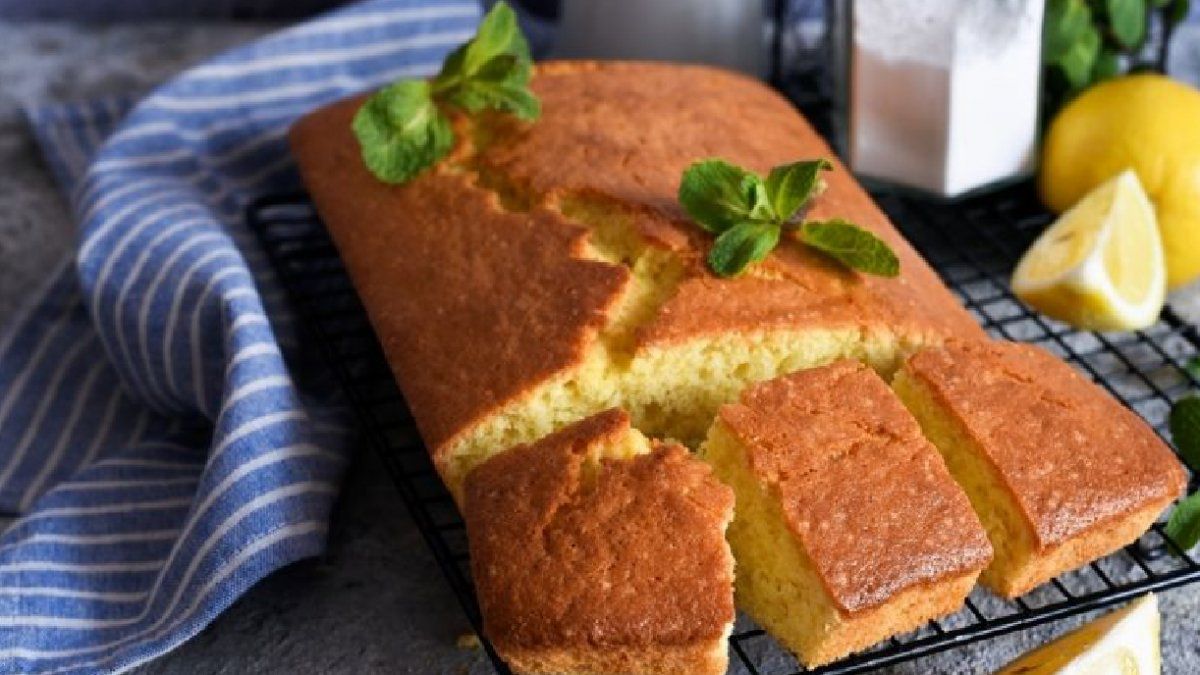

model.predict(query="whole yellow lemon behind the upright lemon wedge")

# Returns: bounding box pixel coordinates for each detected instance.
[1038,74,1200,288]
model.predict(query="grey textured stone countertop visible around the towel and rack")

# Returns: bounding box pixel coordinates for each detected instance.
[0,23,1200,675]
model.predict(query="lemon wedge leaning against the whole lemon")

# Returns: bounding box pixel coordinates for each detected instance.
[1013,171,1166,330]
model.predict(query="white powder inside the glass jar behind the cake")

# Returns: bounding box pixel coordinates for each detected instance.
[850,0,1044,197]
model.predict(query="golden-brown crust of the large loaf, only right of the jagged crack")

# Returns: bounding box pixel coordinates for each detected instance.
[475,62,982,345]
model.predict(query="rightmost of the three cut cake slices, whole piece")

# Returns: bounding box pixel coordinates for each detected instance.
[893,342,1186,597]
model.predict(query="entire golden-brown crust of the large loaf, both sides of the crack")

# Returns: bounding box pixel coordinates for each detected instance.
[290,62,980,454]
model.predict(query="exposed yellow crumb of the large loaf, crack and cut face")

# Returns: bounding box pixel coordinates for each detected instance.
[427,123,926,494]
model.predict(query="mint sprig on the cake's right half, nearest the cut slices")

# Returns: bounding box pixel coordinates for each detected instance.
[679,159,900,276]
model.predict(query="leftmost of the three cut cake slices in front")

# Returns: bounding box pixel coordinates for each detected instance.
[463,410,733,675]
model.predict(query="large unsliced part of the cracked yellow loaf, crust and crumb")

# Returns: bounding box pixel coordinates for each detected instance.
[290,62,982,496]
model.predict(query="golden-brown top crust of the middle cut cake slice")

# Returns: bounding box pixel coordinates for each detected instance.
[721,360,991,614]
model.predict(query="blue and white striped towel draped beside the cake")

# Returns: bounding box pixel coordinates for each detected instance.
[0,0,480,673]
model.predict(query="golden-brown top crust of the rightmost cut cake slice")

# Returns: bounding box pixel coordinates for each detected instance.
[905,341,1187,550]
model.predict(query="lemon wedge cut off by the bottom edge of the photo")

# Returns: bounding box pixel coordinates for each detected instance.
[996,593,1163,675]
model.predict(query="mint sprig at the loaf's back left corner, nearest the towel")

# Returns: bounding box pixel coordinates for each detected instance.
[352,0,541,183]
